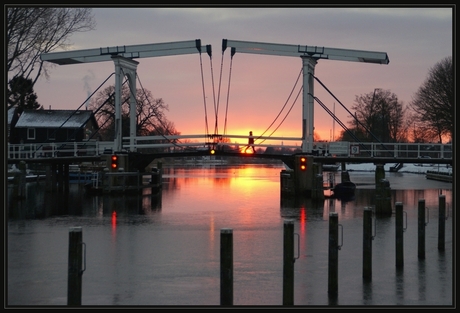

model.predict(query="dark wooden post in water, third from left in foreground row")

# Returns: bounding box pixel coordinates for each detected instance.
[283,220,295,305]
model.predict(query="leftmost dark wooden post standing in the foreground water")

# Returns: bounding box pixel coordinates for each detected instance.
[67,227,83,306]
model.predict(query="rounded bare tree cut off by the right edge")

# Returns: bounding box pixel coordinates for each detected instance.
[410,57,455,142]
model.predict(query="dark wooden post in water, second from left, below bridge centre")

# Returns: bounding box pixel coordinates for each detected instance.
[220,228,233,306]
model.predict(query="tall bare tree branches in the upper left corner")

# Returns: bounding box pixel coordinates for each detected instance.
[5,6,96,106]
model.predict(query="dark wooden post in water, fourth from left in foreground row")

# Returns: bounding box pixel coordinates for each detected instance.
[328,212,339,294]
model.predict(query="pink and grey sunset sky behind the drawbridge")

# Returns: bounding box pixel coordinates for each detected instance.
[34,7,453,145]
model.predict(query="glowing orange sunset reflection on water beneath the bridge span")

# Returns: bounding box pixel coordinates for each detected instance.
[163,165,280,227]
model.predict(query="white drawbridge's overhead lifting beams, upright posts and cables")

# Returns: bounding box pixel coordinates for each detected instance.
[41,39,389,165]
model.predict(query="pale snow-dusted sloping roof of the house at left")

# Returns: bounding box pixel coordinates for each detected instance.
[16,110,93,128]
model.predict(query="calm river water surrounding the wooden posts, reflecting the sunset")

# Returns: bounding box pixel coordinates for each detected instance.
[5,164,455,307]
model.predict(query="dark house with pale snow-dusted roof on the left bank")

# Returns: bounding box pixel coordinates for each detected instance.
[10,109,99,143]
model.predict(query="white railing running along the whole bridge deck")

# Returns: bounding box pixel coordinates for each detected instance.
[7,135,452,159]
